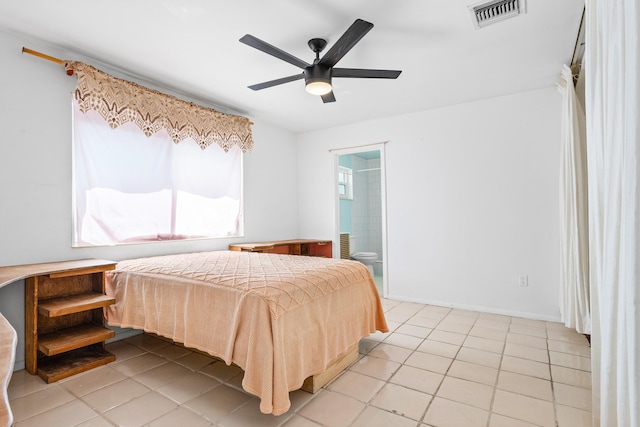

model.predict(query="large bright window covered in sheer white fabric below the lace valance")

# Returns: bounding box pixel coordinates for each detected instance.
[73,99,243,246]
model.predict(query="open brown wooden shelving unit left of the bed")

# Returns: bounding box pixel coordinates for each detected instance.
[18,260,116,383]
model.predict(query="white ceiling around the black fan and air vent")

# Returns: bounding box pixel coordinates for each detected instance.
[0,0,584,132]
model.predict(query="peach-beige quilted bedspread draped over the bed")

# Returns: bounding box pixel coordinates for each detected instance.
[106,251,387,415]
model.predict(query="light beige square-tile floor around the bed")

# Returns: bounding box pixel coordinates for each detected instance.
[9,300,591,427]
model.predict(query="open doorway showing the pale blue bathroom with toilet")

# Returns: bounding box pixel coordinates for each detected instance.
[335,144,387,297]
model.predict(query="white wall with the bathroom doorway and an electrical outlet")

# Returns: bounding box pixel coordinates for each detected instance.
[298,88,560,320]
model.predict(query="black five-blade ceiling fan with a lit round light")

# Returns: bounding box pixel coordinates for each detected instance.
[240,19,402,103]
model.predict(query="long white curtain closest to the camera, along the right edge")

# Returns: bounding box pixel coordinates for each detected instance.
[585,0,640,427]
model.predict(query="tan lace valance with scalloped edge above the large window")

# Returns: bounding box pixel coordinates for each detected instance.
[64,61,253,152]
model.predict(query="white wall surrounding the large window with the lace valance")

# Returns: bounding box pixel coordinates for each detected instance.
[0,32,298,368]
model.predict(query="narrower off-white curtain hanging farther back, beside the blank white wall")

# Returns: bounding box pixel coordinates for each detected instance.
[558,65,591,334]
